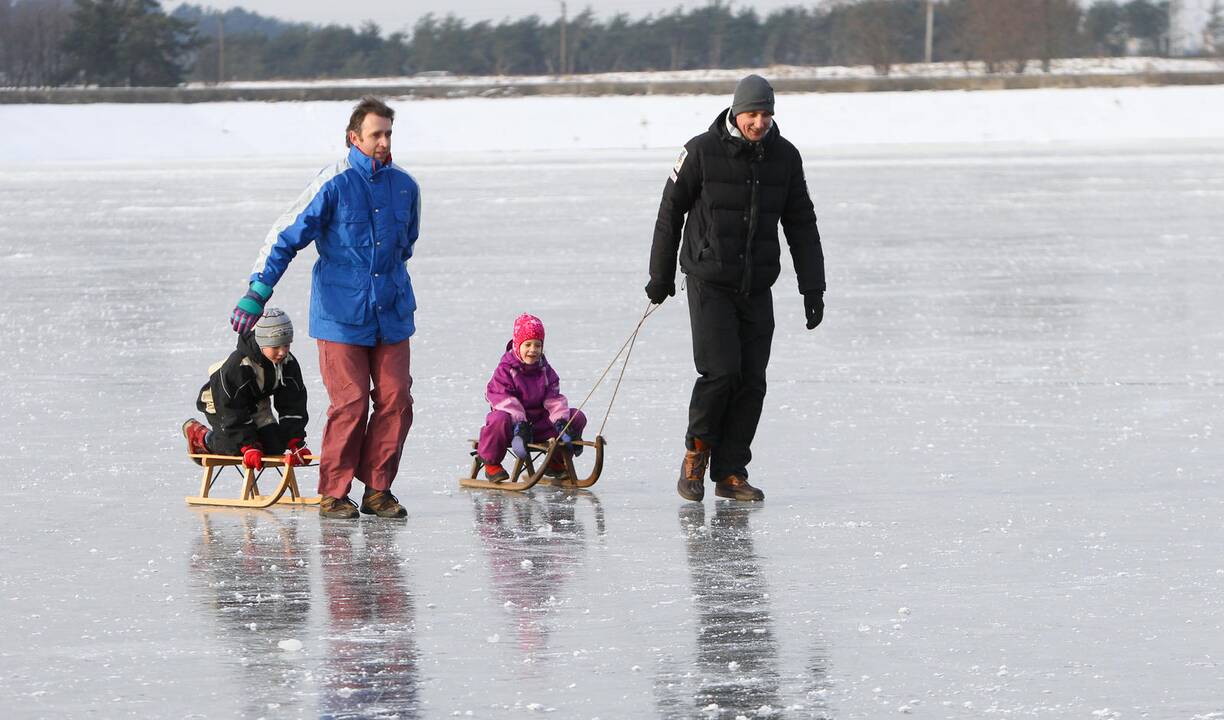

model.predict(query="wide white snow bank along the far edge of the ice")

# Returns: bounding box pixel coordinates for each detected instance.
[9,86,1224,165]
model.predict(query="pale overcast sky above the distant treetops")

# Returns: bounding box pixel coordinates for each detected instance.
[163,0,1211,34]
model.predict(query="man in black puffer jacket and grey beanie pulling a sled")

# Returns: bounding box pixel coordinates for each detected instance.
[646,75,825,501]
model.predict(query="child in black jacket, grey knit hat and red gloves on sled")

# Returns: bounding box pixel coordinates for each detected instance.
[182,307,311,468]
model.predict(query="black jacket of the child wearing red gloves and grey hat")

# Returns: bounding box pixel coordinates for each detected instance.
[196,331,308,451]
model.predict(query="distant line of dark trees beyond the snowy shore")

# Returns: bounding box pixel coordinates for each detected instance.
[0,0,1224,87]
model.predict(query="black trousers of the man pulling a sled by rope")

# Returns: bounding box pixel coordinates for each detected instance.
[688,277,774,480]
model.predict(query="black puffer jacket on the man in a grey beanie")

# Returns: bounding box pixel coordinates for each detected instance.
[650,109,825,294]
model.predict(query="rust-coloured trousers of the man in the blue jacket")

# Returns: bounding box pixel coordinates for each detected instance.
[318,340,412,497]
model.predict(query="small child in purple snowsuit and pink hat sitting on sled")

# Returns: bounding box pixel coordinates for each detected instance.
[476,313,586,482]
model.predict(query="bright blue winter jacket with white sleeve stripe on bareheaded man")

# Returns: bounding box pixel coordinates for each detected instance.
[251,147,421,347]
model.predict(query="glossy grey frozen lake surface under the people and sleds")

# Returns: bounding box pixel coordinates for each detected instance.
[0,138,1224,720]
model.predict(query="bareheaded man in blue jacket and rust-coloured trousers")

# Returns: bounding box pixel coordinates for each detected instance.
[230,97,421,519]
